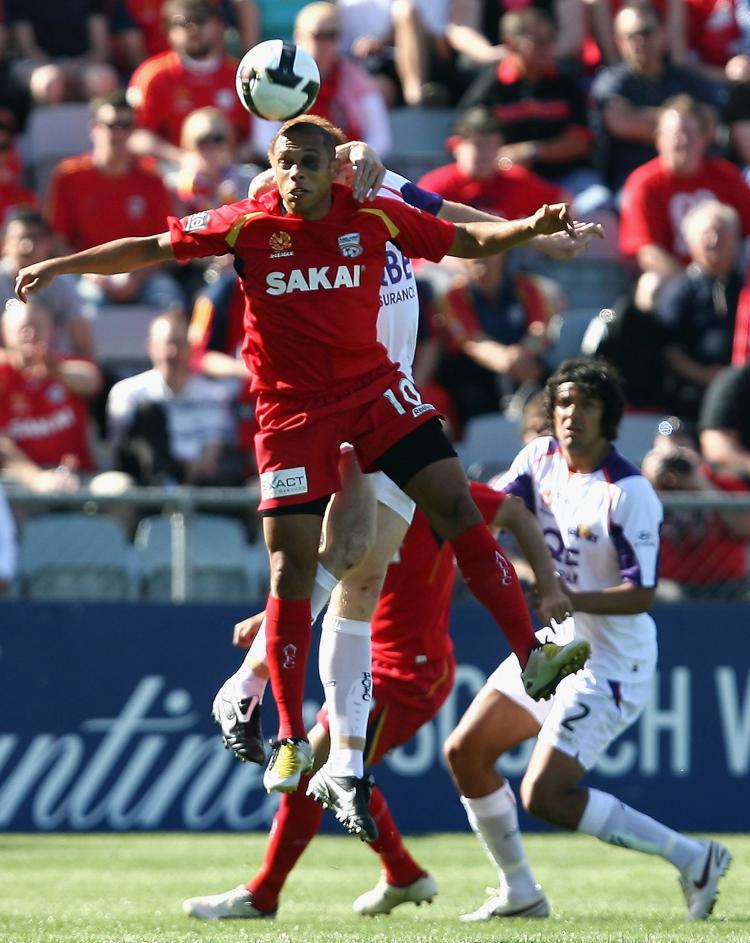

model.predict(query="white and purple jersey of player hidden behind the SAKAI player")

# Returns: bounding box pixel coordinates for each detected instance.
[378,170,443,377]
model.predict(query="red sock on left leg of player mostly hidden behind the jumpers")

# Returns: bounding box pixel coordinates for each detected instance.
[245,776,324,913]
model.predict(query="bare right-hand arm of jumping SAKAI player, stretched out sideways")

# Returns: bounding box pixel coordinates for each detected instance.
[446,203,575,259]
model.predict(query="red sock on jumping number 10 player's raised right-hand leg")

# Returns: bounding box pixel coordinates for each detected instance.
[451,524,536,668]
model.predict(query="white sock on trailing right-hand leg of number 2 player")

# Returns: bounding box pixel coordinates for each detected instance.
[578,789,703,871]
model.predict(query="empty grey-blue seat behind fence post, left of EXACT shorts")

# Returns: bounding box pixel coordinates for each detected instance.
[135,514,257,601]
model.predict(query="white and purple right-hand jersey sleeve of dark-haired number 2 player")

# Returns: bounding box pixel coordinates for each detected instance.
[609,484,663,587]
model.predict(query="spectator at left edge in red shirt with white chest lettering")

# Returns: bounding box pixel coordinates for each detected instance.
[0,301,102,492]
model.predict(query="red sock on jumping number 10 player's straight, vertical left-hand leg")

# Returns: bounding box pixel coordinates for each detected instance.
[266,594,312,740]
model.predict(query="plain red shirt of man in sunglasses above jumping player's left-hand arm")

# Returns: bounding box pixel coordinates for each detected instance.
[47,154,171,252]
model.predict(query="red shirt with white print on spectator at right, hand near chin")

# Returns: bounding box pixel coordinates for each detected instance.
[620,157,750,264]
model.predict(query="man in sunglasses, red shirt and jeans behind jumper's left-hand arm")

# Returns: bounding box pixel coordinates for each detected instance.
[47,92,184,310]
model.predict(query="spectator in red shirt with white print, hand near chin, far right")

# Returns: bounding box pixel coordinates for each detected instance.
[620,95,750,311]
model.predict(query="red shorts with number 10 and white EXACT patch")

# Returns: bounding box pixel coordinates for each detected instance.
[255,367,439,511]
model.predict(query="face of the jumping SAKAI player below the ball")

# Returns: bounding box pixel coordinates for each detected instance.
[271,134,338,219]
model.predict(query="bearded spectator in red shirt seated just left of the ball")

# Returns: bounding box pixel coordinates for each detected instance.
[128,0,250,163]
